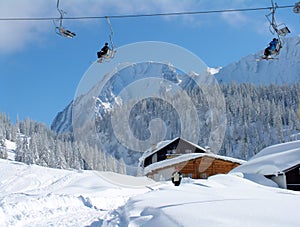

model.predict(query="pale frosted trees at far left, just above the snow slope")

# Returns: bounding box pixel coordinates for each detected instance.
[0,113,126,173]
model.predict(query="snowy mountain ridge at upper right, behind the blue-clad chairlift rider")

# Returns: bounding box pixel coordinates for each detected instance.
[215,35,300,85]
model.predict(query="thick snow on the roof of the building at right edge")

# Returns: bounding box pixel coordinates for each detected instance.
[231,140,300,175]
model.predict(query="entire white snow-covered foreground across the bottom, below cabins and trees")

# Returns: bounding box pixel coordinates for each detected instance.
[0,160,300,226]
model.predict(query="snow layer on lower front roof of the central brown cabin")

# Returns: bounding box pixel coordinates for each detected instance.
[144,153,246,175]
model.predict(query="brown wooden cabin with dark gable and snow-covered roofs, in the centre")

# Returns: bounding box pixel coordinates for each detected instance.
[140,138,245,180]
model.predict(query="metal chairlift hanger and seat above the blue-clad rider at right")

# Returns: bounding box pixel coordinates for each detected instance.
[266,0,291,37]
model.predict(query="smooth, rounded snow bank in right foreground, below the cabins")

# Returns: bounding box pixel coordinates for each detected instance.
[103,175,300,226]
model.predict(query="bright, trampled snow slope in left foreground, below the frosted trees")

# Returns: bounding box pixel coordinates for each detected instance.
[0,159,157,226]
